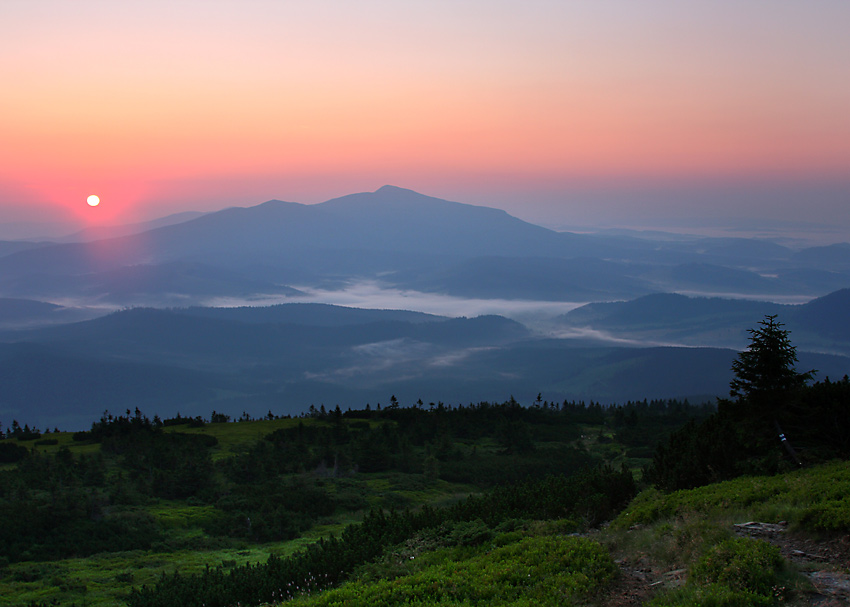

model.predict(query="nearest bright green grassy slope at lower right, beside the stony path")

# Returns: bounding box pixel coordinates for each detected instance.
[270,462,850,607]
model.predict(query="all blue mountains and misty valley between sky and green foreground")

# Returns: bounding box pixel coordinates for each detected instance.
[0,186,850,428]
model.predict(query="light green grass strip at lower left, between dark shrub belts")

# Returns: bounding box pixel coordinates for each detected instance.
[0,470,474,607]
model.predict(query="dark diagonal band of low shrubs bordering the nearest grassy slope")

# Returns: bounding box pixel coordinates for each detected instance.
[122,467,635,607]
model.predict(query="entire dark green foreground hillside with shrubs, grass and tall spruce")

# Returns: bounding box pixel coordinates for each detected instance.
[0,316,850,607]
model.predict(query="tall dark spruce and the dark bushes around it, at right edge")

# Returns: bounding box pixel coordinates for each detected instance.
[644,316,850,491]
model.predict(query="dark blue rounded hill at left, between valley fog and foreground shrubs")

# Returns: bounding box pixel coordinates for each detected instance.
[0,306,529,427]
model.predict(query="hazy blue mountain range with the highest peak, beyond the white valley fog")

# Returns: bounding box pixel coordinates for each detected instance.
[0,186,850,305]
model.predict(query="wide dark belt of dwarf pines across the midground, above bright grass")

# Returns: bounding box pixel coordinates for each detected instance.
[0,398,710,566]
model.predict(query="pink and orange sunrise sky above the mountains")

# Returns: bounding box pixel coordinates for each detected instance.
[0,0,850,240]
